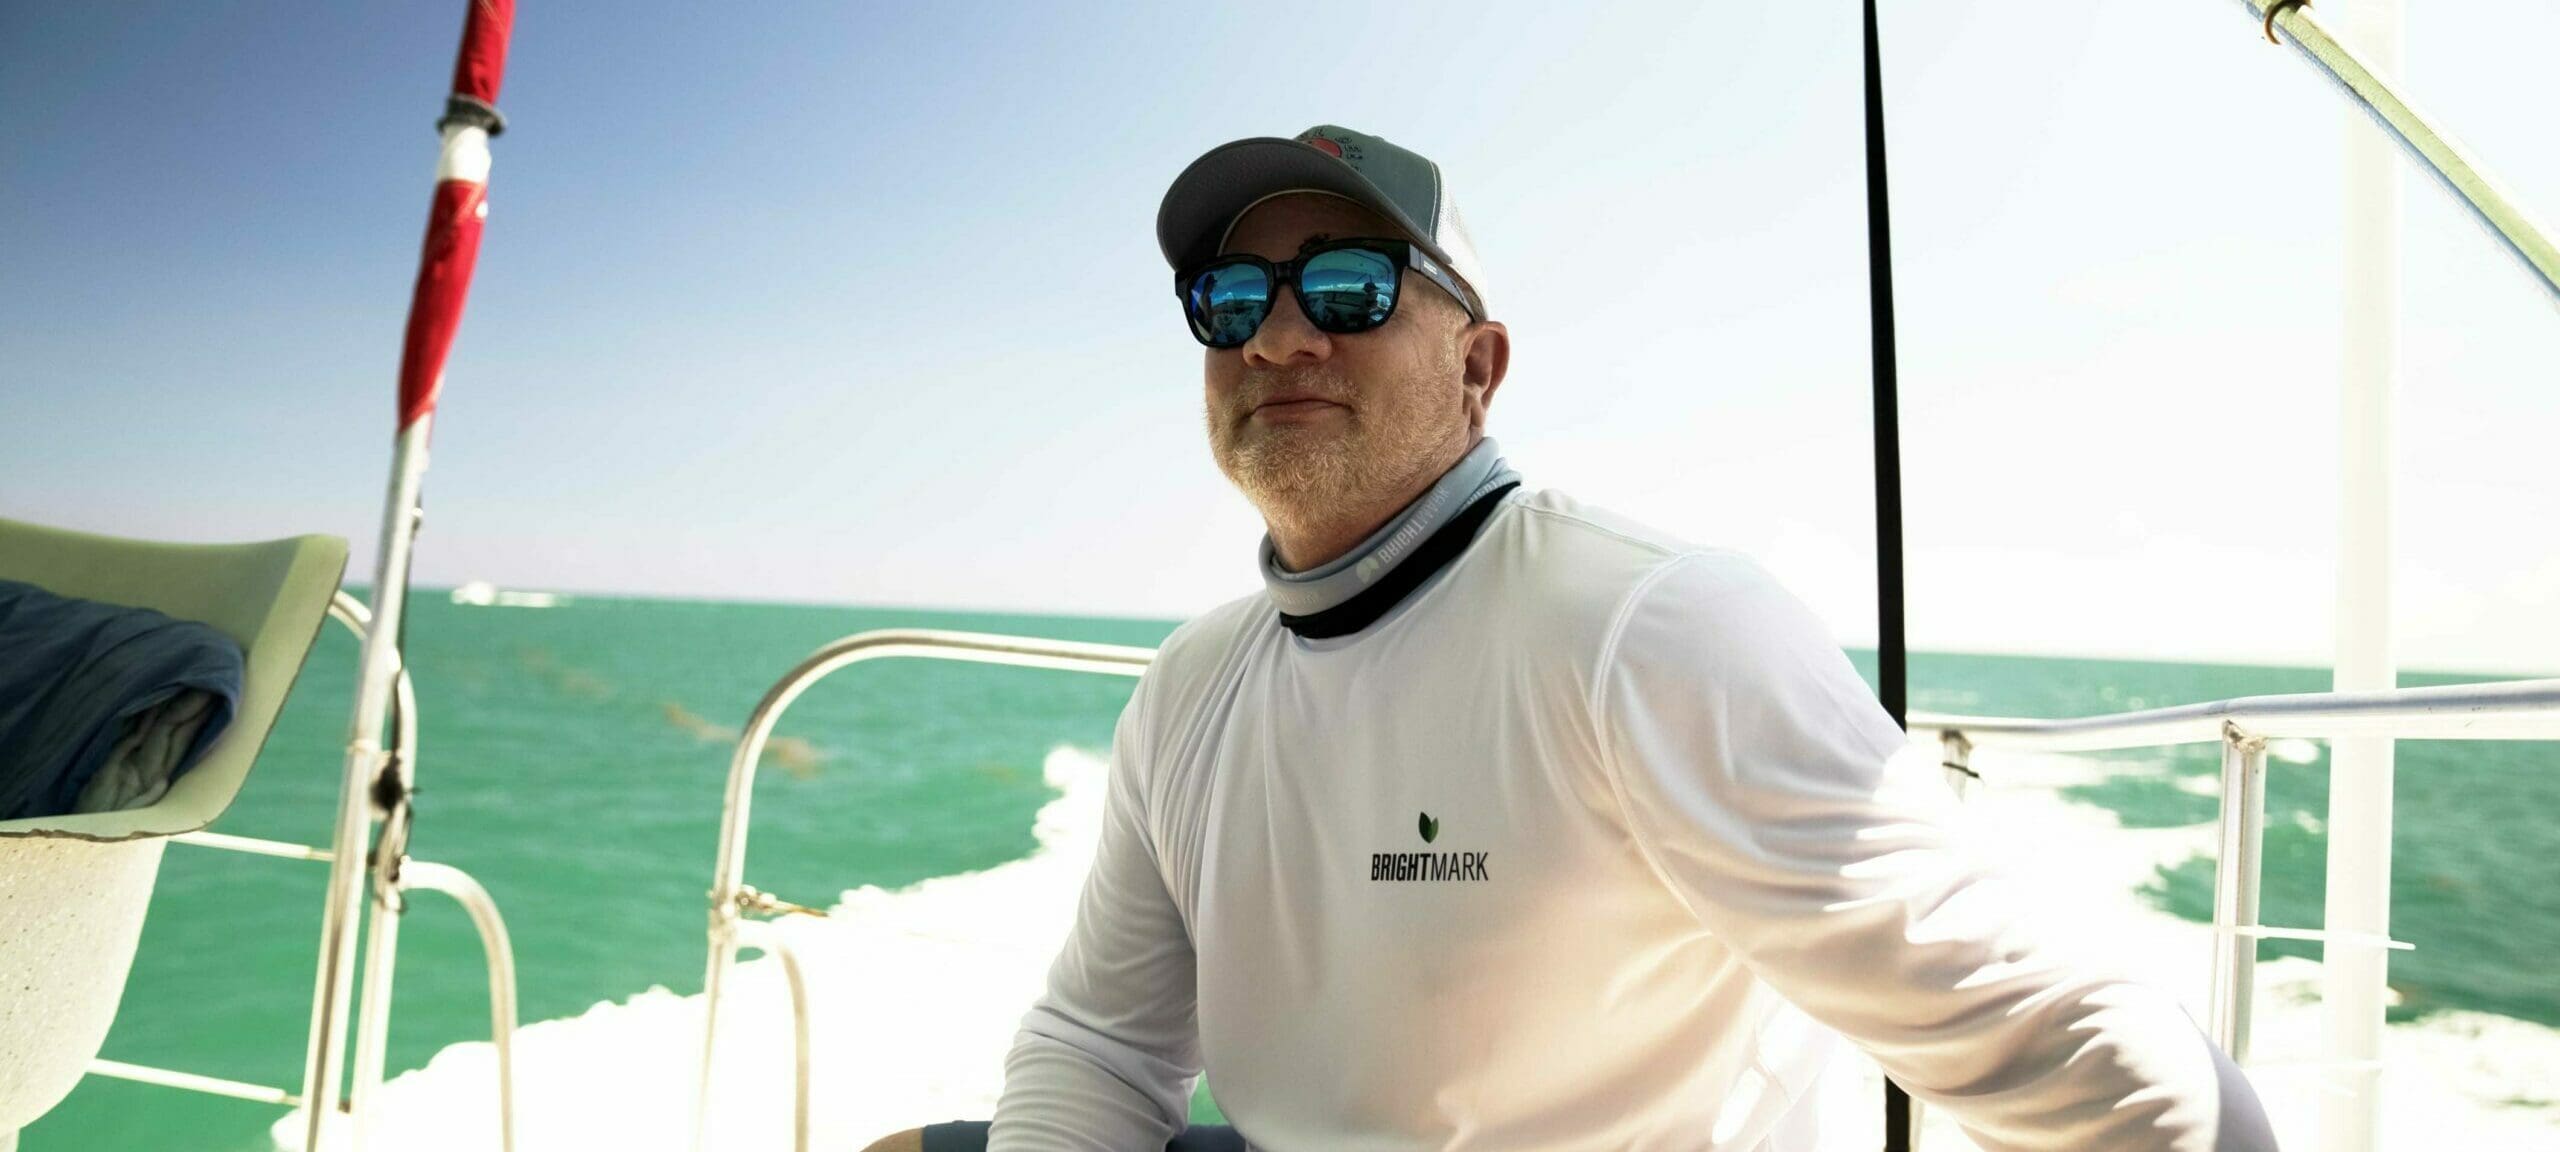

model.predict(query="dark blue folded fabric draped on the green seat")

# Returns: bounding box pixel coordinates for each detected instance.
[0,581,246,819]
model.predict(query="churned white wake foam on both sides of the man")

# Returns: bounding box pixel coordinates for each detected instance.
[274,748,2560,1152]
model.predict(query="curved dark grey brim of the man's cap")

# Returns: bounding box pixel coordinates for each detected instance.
[1155,136,1449,271]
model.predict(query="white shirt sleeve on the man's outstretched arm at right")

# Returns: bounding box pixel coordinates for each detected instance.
[1592,553,2276,1152]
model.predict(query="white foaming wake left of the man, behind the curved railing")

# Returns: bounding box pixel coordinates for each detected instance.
[274,748,1108,1152]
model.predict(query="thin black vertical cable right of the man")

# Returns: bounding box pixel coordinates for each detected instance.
[1864,0,1912,1152]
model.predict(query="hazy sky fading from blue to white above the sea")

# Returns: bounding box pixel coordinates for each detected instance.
[0,0,2560,671]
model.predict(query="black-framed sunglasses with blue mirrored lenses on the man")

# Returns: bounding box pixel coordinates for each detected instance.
[1172,238,1482,348]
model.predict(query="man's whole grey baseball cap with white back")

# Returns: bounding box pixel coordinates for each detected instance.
[1155,123,1490,317]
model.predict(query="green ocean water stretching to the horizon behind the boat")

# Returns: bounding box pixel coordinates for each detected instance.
[23,594,2560,1152]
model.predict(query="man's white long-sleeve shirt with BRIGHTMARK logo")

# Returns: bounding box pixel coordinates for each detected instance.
[991,492,2273,1152]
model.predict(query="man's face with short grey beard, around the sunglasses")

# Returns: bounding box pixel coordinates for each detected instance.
[1206,195,1490,517]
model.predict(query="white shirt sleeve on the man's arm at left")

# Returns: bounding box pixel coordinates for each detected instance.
[988,681,1201,1152]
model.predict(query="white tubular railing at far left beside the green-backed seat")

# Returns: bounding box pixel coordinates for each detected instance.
[90,591,515,1152]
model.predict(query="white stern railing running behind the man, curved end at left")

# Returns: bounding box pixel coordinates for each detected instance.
[694,630,2560,1152]
